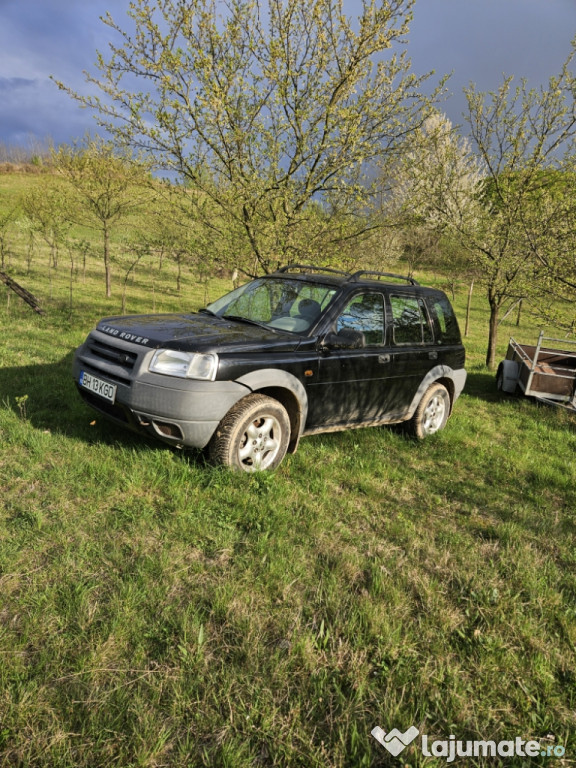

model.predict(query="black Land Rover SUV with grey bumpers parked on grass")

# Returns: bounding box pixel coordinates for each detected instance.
[74,265,466,472]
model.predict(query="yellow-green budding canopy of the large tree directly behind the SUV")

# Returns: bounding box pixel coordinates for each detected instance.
[59,0,434,270]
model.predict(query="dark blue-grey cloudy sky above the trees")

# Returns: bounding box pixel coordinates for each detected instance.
[0,0,576,152]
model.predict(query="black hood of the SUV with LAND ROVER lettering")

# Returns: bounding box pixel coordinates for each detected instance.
[97,313,301,353]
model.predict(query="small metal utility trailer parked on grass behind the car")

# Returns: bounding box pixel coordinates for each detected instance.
[496,331,576,410]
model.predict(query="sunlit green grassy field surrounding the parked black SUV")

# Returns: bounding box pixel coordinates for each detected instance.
[0,174,576,768]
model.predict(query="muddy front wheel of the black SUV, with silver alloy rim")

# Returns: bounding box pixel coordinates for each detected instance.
[208,394,290,472]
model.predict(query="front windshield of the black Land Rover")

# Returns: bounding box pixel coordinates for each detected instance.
[207,277,337,333]
